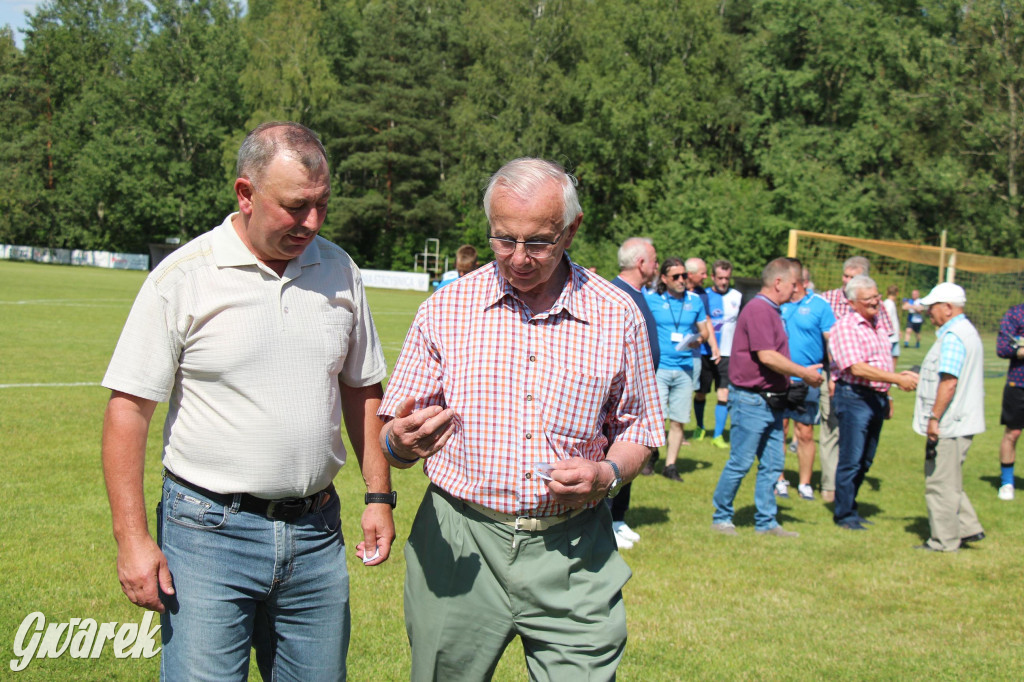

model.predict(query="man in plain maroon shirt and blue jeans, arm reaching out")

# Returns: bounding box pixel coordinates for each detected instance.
[711,258,822,538]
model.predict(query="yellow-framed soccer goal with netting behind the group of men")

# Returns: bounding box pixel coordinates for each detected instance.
[788,229,1024,331]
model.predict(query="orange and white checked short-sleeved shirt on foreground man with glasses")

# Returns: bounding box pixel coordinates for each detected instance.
[378,261,665,516]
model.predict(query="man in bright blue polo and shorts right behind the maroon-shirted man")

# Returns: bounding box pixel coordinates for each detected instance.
[775,267,836,500]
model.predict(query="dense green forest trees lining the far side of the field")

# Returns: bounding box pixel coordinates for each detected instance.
[6,0,1024,274]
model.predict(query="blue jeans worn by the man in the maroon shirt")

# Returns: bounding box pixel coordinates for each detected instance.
[712,386,785,530]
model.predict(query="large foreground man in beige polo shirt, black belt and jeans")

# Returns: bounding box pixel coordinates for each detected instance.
[102,123,394,680]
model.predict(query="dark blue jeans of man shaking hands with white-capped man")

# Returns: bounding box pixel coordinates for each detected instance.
[833,383,889,523]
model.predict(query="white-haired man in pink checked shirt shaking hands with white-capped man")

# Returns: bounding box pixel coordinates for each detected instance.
[828,274,918,530]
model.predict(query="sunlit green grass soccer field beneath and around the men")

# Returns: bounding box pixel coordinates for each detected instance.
[0,262,1024,680]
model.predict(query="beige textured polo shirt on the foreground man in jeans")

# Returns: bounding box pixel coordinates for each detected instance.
[102,216,387,498]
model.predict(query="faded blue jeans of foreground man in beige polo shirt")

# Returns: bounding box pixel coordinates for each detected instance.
[157,478,349,681]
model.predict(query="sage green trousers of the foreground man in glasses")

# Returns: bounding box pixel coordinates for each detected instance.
[404,485,632,682]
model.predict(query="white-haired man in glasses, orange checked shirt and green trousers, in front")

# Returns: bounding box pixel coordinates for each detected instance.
[379,159,664,680]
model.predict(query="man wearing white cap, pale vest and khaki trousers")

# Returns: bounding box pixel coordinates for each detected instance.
[913,282,985,552]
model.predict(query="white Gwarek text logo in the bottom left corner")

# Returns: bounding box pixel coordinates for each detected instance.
[10,611,162,673]
